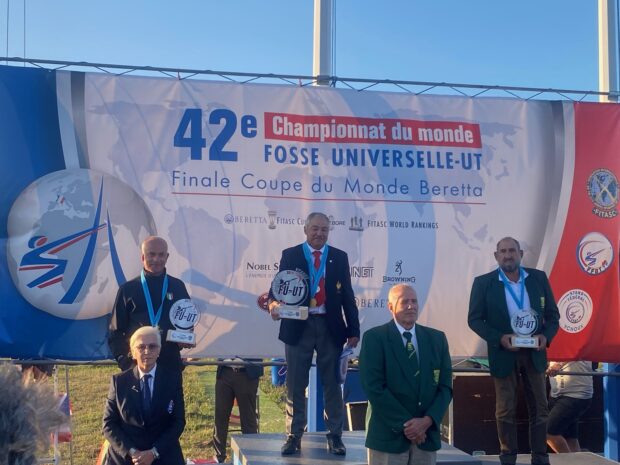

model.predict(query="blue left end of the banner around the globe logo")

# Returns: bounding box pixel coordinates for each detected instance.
[0,66,110,360]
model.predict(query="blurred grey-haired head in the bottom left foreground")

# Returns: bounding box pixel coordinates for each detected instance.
[0,364,68,465]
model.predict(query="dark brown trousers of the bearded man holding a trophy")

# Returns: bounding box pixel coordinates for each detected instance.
[493,349,549,465]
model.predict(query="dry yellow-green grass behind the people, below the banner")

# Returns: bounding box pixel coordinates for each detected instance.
[46,366,285,465]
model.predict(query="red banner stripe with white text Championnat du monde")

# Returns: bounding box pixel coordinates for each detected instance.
[264,112,482,148]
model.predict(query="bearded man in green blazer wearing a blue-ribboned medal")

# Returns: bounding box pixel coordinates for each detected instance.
[468,237,560,465]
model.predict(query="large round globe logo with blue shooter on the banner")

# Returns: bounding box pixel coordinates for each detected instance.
[7,169,156,320]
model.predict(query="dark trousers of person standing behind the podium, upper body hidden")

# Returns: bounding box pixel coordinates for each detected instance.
[213,367,258,462]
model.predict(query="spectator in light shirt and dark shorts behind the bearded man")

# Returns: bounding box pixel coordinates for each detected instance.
[547,361,594,452]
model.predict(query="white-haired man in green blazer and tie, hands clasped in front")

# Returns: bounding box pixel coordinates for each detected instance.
[359,284,452,465]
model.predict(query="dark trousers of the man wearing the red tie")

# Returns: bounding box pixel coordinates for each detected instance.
[284,315,344,436]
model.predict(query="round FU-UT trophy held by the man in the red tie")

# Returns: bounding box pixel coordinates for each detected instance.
[271,270,309,320]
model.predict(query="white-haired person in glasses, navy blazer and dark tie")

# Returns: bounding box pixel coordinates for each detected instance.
[103,326,185,465]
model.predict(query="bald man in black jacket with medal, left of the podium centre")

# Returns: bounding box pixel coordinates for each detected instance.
[108,236,189,372]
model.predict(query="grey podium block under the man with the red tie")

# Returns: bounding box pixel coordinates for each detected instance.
[231,431,482,465]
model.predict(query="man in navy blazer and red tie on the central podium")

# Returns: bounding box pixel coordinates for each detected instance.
[269,212,360,455]
